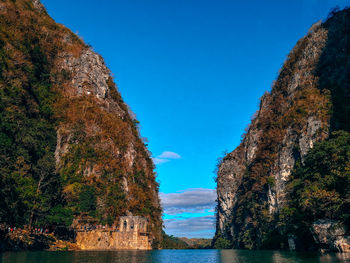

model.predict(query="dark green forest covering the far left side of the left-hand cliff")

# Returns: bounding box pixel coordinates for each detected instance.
[0,0,62,229]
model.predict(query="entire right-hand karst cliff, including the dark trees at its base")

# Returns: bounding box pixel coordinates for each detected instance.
[214,8,350,254]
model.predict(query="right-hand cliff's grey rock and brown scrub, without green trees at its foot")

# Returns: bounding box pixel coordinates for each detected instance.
[214,7,349,252]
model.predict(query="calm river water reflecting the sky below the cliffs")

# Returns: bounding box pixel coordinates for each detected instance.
[0,252,350,263]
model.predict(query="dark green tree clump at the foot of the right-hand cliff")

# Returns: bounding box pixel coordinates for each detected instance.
[279,131,350,250]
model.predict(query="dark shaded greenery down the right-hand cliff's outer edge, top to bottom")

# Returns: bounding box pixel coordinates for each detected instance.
[279,8,350,248]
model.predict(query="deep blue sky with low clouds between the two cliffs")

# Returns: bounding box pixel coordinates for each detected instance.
[42,0,349,237]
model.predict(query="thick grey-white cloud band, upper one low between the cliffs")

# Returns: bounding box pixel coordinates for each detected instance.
[159,188,216,215]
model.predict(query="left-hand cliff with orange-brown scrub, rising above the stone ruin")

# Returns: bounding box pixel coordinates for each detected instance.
[0,0,162,248]
